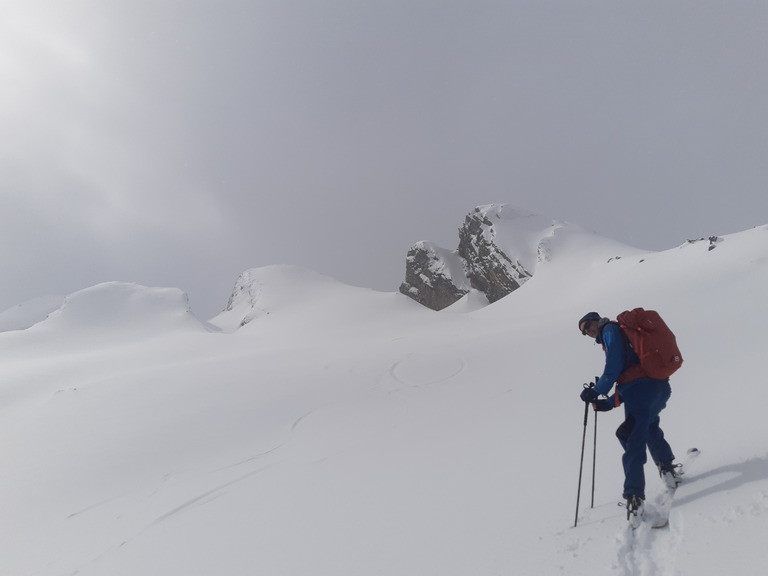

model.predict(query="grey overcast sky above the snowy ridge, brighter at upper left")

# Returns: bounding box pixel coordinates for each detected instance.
[0,0,768,318]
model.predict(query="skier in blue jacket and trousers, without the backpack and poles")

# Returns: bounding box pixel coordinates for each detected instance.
[579,312,681,519]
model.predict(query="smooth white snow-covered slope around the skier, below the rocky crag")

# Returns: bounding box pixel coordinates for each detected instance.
[0,226,768,576]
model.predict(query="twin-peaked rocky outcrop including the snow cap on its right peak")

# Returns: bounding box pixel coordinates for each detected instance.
[400,204,554,310]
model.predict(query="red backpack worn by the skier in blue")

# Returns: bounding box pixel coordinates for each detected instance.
[616,308,683,382]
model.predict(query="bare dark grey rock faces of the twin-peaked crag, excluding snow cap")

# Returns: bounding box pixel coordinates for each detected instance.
[400,205,533,310]
